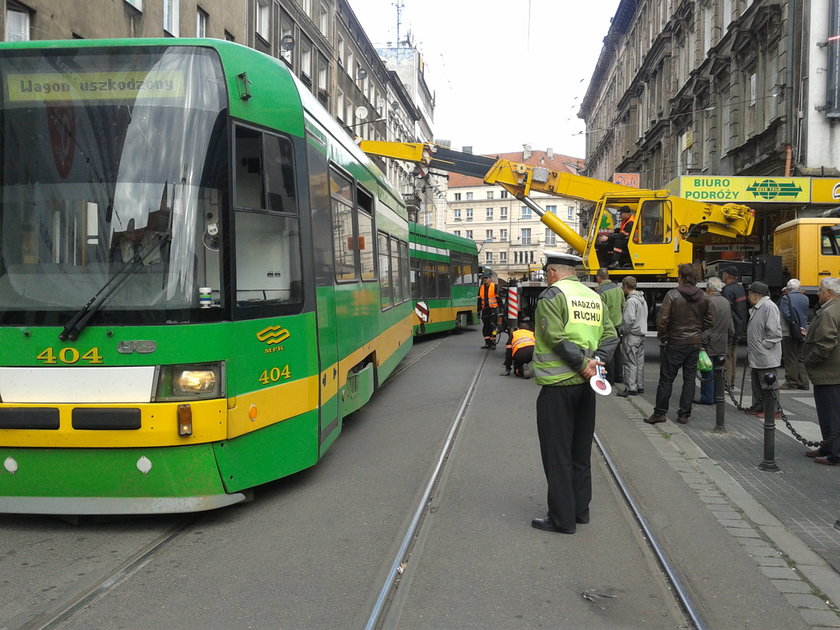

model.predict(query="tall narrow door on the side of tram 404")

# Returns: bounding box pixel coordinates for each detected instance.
[306,136,340,457]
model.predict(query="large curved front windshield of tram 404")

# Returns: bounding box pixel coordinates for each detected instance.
[0,47,228,324]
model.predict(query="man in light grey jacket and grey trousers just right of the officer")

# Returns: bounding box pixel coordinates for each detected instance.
[618,276,648,396]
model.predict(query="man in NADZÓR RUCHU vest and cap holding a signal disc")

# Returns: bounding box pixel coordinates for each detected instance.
[531,252,618,534]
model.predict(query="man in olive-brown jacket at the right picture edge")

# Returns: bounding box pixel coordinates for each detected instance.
[803,278,840,466]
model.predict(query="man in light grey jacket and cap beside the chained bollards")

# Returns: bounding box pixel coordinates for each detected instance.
[745,282,782,418]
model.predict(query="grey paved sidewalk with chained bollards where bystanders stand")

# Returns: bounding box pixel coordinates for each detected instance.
[613,338,840,627]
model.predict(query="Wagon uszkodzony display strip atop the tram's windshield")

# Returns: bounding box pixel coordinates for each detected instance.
[6,70,184,102]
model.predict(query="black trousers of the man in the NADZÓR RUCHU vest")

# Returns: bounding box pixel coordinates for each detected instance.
[537,383,595,531]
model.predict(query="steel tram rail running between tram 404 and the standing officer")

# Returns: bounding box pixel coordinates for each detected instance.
[365,346,490,630]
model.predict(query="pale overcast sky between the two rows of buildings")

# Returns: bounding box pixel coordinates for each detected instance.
[349,0,619,158]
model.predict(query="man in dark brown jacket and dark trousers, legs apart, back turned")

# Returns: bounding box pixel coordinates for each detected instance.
[645,264,714,424]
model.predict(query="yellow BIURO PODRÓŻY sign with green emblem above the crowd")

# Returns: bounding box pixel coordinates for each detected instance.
[679,175,811,203]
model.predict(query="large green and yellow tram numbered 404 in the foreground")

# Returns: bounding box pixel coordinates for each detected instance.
[0,39,414,514]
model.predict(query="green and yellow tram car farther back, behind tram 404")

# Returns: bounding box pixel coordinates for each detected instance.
[409,223,479,335]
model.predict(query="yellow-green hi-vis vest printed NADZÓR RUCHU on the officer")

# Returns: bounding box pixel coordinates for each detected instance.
[531,277,605,385]
